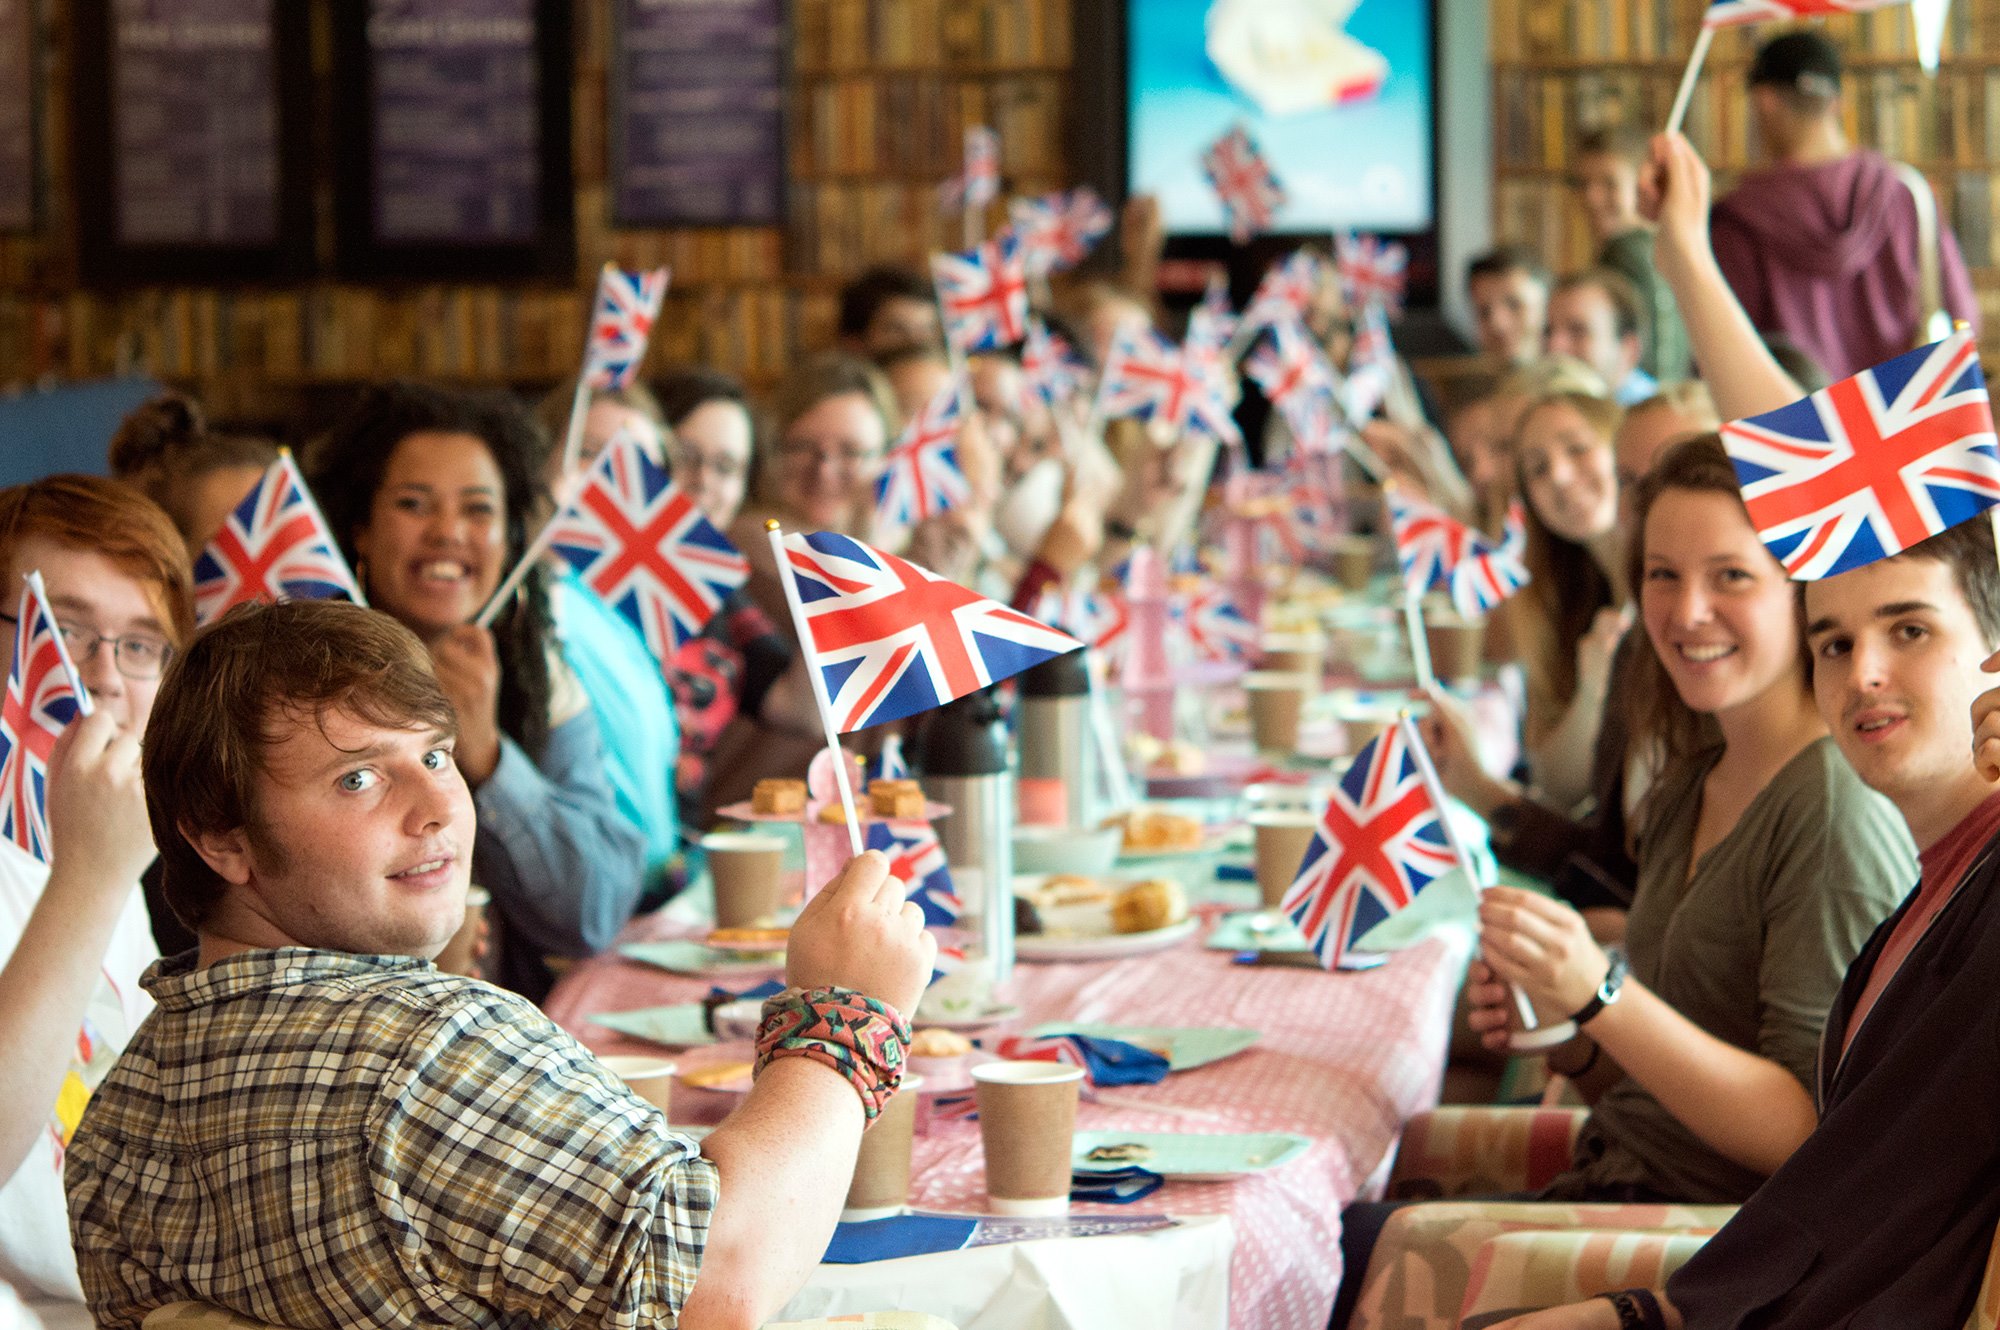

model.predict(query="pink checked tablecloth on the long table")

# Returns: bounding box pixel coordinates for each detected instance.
[546,916,1464,1330]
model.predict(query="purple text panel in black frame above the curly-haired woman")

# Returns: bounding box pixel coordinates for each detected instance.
[368,0,542,244]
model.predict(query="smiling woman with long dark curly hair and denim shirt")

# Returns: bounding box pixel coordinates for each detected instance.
[308,384,646,1000]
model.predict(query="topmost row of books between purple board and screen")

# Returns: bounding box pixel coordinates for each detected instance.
[792,0,1072,74]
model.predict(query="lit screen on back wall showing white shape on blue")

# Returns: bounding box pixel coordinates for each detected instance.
[1126,0,1436,234]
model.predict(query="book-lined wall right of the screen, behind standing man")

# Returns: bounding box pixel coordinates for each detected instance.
[1492,0,2000,358]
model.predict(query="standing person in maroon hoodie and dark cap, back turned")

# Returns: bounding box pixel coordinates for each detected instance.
[1702,30,1978,378]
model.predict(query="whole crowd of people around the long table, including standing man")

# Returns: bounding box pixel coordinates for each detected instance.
[0,34,2000,1330]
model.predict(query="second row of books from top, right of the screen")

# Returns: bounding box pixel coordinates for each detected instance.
[1494,64,2000,172]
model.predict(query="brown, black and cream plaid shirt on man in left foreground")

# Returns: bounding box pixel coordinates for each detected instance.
[66,948,718,1330]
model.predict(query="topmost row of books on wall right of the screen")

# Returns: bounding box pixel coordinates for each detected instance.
[1490,0,2000,64]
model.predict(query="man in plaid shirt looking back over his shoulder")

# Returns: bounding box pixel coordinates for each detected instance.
[66,602,934,1330]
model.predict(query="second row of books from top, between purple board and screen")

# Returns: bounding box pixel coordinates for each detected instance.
[790,74,1064,182]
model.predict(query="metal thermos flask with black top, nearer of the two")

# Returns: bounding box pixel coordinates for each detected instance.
[920,688,1014,984]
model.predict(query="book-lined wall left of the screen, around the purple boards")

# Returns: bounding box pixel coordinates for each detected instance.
[0,0,1070,418]
